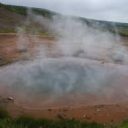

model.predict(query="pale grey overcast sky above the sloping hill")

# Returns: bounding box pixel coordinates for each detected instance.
[0,0,128,23]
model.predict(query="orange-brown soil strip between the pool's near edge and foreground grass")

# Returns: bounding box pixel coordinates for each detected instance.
[5,103,128,123]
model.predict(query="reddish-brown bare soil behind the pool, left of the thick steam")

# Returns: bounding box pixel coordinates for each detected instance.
[0,33,53,66]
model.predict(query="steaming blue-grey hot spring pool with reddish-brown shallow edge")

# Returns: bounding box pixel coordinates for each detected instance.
[0,57,128,107]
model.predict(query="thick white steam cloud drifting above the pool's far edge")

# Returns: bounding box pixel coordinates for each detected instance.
[31,14,128,64]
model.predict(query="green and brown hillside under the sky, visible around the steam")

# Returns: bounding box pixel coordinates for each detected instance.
[0,3,128,36]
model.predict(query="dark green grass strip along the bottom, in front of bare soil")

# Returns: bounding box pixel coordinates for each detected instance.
[0,108,128,128]
